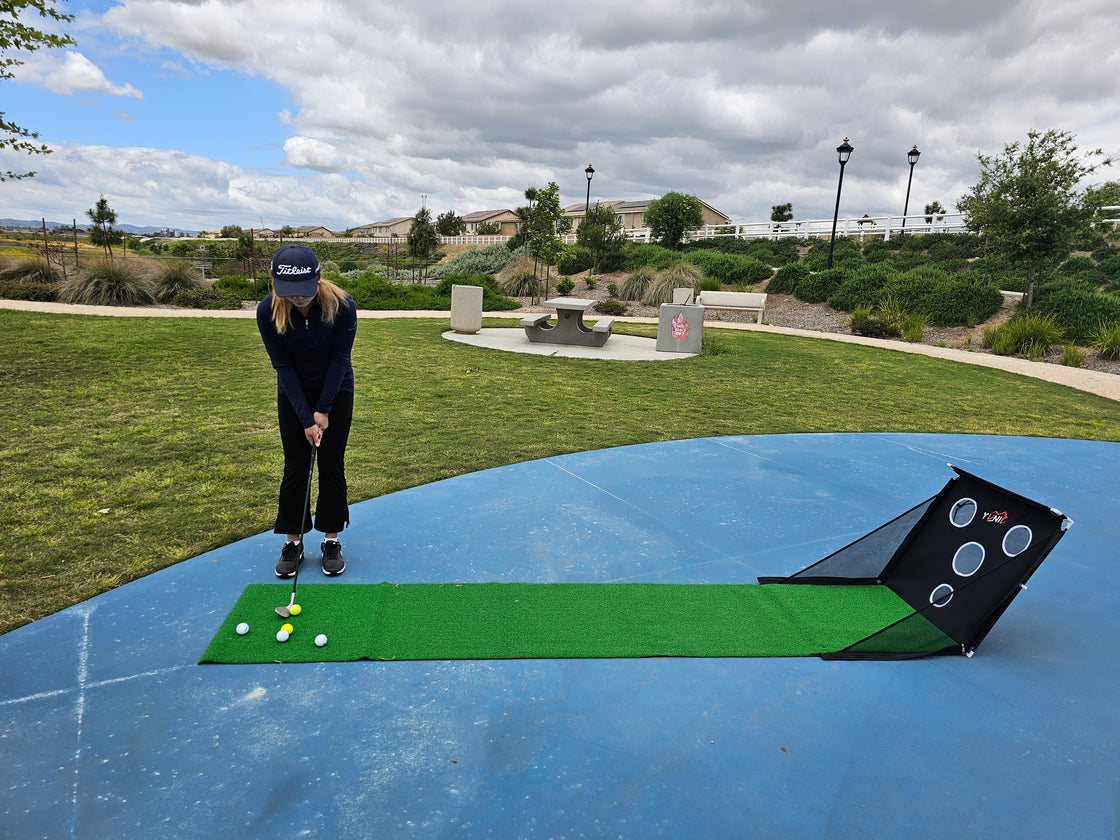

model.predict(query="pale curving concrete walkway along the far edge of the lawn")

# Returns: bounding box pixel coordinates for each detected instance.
[0,300,1120,401]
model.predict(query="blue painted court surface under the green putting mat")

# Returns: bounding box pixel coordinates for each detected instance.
[0,433,1120,840]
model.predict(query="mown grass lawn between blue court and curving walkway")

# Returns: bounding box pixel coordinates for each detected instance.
[0,310,1120,633]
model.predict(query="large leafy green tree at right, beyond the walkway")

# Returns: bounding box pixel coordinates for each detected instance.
[956,129,1112,308]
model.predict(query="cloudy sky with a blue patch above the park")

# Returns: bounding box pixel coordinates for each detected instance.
[0,0,1120,230]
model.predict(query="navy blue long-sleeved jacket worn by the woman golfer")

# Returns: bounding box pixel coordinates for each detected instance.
[256,295,357,429]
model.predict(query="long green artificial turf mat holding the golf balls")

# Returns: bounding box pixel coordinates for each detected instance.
[200,584,952,663]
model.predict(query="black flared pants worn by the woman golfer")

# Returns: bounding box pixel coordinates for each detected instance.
[274,392,354,534]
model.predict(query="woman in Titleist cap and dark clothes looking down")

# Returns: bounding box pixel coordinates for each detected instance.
[256,245,357,578]
